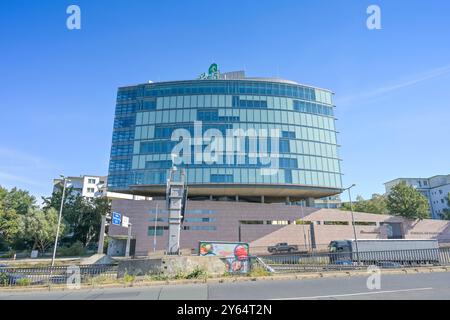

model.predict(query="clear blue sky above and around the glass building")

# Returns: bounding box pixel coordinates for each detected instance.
[0,0,450,199]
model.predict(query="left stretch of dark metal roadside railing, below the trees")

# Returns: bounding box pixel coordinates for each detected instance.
[0,264,117,287]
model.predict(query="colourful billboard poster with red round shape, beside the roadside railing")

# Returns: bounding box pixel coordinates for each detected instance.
[199,241,250,273]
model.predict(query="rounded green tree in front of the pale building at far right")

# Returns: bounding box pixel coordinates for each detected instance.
[387,182,430,219]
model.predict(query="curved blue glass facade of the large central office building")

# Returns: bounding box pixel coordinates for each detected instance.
[108,80,342,198]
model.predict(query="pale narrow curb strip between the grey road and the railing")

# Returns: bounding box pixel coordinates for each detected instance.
[0,267,450,293]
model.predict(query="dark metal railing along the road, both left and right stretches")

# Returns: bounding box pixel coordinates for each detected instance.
[0,247,450,287]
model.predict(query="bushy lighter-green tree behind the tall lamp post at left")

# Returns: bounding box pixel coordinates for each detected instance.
[22,208,65,253]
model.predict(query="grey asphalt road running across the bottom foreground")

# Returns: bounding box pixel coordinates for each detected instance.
[0,272,450,300]
